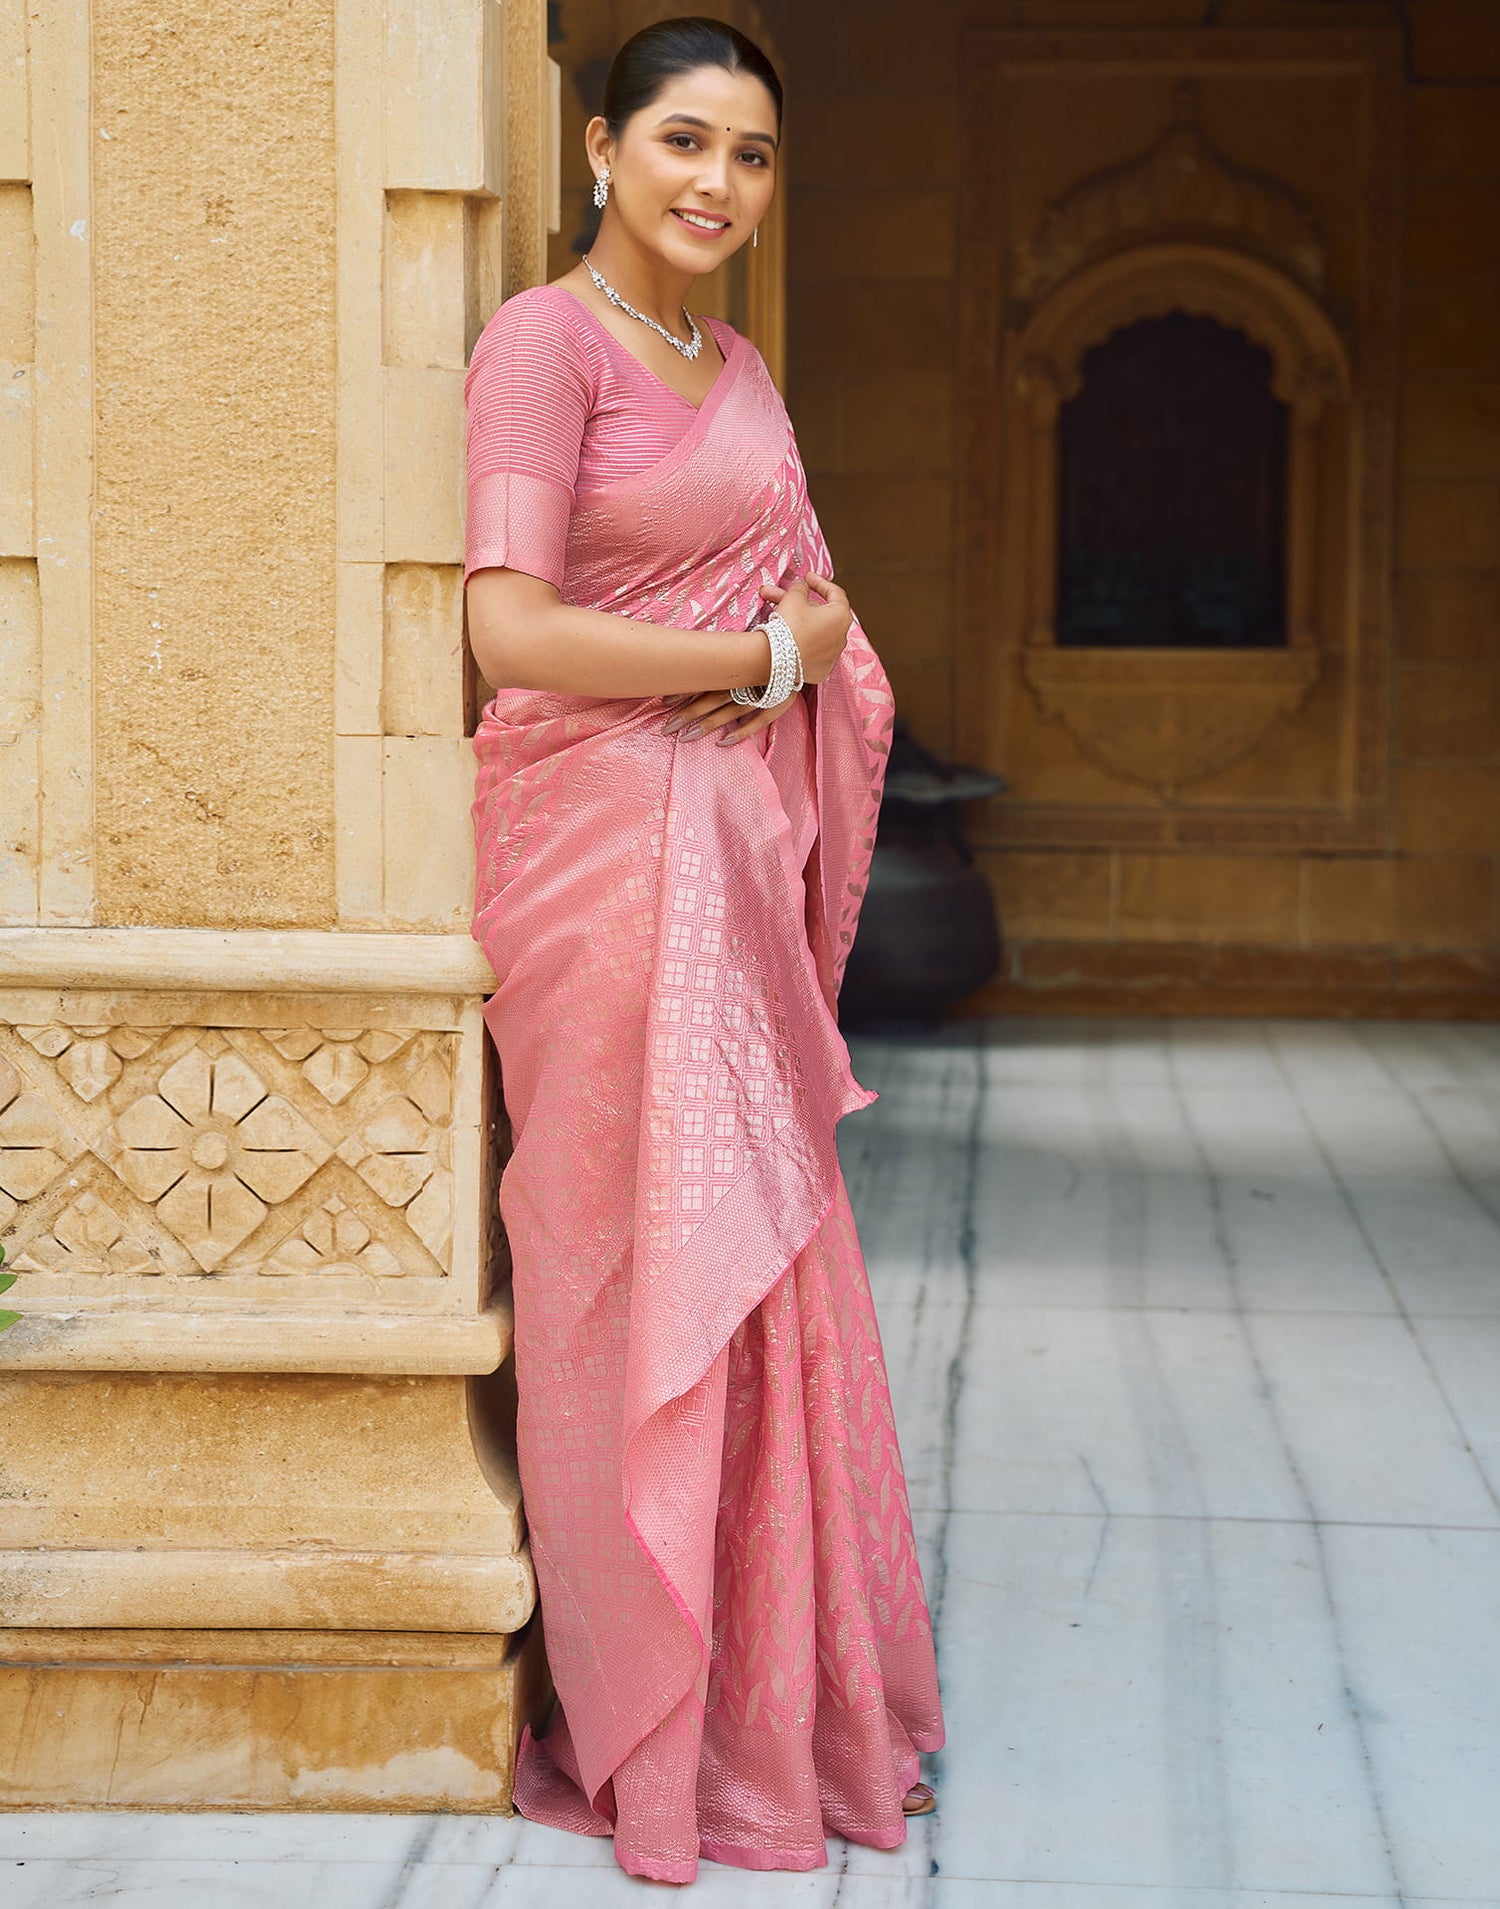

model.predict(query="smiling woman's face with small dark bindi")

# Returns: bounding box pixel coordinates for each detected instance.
[605,67,777,277]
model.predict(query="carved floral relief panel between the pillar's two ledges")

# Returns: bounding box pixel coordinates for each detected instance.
[0,996,460,1283]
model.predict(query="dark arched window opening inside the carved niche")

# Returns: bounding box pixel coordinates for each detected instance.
[1057,311,1286,649]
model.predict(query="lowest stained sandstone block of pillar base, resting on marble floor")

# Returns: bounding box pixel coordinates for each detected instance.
[0,1626,550,1814]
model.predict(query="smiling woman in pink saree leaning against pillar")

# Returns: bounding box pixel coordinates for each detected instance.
[464,17,943,1882]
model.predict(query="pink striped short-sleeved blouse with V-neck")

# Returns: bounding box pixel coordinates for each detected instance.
[464,284,740,590]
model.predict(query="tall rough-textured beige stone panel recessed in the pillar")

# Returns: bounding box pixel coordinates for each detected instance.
[93,0,338,928]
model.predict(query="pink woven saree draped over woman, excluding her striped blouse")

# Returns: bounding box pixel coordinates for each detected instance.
[473,338,943,1882]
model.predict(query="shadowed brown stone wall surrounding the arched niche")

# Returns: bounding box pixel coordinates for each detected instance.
[767,0,1500,1014]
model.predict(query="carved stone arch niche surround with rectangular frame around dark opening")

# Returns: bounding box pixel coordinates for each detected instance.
[958,32,1395,846]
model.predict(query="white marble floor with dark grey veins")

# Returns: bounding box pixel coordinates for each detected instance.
[0,1021,1500,1909]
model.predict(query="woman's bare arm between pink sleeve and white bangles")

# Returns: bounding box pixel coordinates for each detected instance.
[466,567,771,697]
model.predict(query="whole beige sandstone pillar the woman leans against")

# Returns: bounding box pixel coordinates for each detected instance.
[0,0,555,1810]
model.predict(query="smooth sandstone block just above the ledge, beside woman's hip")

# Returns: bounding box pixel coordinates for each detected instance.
[384,735,475,932]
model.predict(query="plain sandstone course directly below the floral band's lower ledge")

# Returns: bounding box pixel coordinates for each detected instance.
[0,1374,523,1550]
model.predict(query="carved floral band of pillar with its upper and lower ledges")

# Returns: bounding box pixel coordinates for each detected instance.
[0,930,510,1373]
